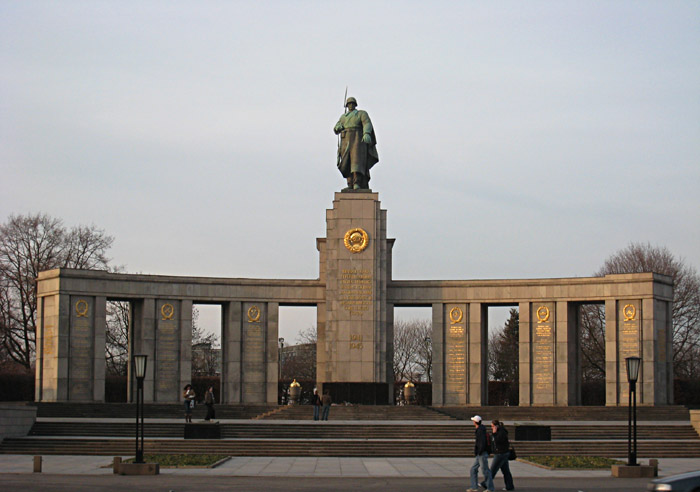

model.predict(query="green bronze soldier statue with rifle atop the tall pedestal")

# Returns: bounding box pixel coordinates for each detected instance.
[333,97,379,191]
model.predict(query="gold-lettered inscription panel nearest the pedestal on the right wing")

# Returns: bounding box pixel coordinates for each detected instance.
[443,304,469,405]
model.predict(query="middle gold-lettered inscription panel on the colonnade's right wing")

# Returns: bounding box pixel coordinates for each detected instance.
[530,302,556,405]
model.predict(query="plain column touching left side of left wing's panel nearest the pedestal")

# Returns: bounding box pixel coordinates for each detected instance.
[221,301,243,403]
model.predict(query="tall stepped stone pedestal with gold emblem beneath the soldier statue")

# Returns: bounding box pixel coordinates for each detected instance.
[317,192,393,401]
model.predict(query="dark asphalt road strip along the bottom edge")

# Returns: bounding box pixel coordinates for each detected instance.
[0,473,649,492]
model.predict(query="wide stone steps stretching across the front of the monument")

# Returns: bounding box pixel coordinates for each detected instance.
[0,404,700,458]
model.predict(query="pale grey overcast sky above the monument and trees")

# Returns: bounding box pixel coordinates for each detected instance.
[0,0,700,340]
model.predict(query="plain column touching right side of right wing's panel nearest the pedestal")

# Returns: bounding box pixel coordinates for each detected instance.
[467,302,488,405]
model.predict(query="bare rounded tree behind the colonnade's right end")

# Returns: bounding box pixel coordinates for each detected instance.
[596,243,700,379]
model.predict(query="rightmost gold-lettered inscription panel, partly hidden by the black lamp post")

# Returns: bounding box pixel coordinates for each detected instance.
[617,300,643,405]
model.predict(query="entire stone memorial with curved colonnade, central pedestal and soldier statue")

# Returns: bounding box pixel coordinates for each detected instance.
[35,98,673,406]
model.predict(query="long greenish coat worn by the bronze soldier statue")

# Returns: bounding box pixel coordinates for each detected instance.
[335,109,379,181]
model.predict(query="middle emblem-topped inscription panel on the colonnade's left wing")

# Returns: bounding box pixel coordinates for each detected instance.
[154,301,180,401]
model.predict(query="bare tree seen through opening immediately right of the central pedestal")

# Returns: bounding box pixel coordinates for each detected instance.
[394,319,432,381]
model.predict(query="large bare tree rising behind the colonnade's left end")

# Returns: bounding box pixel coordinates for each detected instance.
[0,214,114,368]
